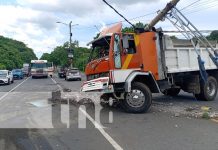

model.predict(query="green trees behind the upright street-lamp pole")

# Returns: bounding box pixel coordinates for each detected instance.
[40,41,90,71]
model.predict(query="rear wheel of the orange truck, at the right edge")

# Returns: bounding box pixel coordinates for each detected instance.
[195,76,218,101]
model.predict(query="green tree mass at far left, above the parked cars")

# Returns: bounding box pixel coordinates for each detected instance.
[0,36,37,70]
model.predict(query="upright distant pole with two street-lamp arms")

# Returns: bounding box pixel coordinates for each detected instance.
[57,21,79,68]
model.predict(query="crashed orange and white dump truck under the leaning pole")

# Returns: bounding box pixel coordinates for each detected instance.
[81,0,218,113]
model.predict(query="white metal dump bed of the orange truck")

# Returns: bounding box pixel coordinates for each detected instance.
[162,36,218,73]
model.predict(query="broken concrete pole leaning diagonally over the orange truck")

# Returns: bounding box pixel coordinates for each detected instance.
[145,0,180,31]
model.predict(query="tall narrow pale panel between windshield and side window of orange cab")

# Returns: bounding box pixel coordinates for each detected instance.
[113,34,122,69]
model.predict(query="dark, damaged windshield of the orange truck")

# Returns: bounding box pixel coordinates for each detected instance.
[89,37,111,61]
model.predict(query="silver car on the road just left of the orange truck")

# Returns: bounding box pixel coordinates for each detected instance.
[65,68,82,81]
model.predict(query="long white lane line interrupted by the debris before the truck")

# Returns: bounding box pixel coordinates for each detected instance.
[51,78,123,150]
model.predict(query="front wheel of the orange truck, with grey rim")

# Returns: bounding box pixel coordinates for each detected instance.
[121,82,152,113]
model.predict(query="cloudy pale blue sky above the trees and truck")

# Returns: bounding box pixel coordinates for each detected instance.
[0,0,218,58]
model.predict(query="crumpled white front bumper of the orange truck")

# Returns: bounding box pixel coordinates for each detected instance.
[81,77,114,93]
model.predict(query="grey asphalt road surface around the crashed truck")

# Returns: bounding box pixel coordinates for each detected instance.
[0,75,218,150]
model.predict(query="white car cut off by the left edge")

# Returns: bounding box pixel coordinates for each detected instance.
[0,70,14,85]
